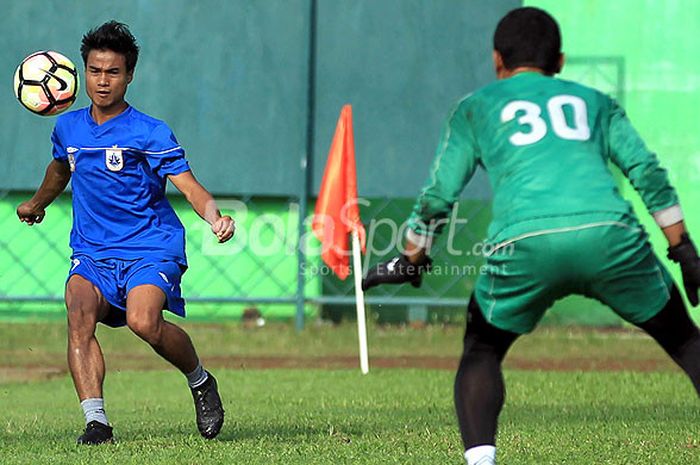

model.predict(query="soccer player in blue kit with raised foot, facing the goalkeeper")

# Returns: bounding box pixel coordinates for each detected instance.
[17,21,235,444]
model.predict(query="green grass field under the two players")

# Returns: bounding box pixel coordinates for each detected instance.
[0,323,700,465]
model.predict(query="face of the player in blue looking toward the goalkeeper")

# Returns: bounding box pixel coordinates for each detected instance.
[85,50,133,112]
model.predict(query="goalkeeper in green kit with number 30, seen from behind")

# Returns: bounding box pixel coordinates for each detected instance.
[363,8,700,465]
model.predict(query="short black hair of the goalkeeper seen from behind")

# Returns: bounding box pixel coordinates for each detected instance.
[493,7,561,74]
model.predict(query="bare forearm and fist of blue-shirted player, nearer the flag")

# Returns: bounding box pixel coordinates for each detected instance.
[168,171,236,242]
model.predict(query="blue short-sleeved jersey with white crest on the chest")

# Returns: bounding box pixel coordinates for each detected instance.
[51,107,189,266]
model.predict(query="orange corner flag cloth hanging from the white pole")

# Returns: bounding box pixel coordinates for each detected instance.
[311,105,365,279]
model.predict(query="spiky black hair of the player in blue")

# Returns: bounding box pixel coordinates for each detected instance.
[80,20,139,72]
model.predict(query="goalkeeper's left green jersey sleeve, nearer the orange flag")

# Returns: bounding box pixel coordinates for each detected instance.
[407,99,479,243]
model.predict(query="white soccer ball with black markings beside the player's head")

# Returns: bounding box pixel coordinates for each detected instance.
[15,51,78,116]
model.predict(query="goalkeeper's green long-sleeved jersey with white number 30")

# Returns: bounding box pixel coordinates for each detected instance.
[409,72,678,244]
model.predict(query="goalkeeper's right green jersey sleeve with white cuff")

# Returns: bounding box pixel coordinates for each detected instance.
[609,101,683,228]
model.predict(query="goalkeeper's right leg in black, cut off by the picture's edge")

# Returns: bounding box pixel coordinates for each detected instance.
[638,286,700,396]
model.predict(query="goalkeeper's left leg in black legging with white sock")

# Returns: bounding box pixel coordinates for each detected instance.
[455,296,518,464]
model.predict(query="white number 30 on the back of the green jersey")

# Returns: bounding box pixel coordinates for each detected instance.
[501,95,591,145]
